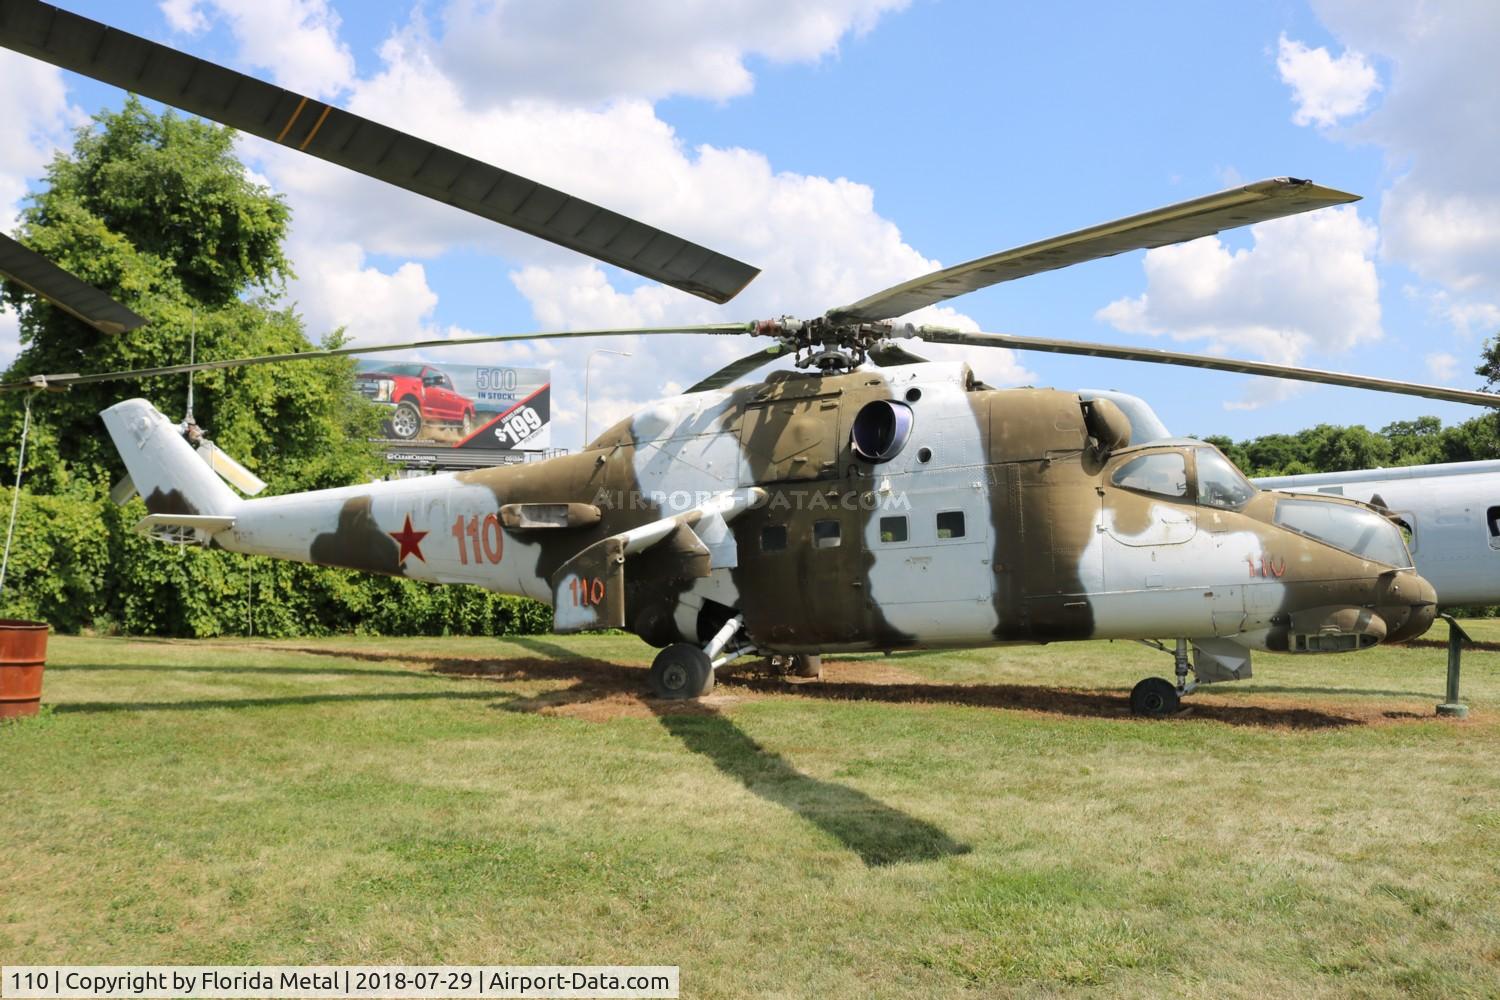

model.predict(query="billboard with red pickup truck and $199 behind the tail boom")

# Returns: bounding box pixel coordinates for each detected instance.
[354,358,552,451]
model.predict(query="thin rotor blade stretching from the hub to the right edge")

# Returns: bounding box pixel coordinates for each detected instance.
[917,327,1500,406]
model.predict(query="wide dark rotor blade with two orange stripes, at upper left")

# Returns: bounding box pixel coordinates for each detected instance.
[0,0,761,303]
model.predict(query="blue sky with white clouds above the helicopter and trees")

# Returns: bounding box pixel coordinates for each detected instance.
[0,0,1500,447]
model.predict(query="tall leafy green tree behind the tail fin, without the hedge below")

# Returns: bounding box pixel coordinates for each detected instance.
[3,97,378,492]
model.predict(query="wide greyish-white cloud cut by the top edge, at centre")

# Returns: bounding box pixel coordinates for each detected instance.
[429,0,908,106]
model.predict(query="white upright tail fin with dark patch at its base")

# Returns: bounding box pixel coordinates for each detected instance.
[99,399,240,516]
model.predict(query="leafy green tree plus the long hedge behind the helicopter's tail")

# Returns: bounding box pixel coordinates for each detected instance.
[0,99,551,636]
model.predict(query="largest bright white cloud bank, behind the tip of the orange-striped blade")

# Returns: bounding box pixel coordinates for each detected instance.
[178,0,1035,445]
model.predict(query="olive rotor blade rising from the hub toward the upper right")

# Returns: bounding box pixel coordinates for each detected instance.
[828,177,1359,322]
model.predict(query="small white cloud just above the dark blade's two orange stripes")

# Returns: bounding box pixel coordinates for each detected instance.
[159,0,354,97]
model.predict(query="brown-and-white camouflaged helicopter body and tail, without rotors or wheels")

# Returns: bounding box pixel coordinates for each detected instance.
[104,363,1434,671]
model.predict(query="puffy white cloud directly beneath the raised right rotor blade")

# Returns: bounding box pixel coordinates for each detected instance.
[1097,207,1382,393]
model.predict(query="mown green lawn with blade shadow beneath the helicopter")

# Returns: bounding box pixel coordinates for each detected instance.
[0,622,1500,1000]
